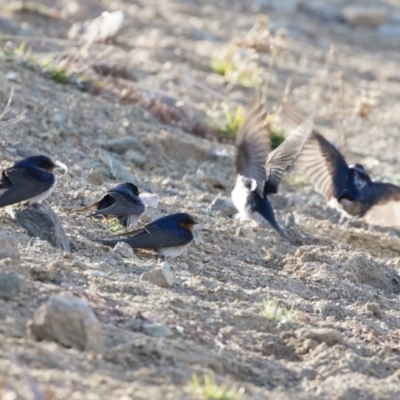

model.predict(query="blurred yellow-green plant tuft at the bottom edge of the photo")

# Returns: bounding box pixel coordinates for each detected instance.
[189,374,244,400]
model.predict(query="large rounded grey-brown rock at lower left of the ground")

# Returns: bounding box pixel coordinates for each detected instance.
[27,293,104,352]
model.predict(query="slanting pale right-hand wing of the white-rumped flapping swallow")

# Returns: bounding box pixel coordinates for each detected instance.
[264,112,313,196]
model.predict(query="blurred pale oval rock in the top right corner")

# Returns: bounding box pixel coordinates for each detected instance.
[342,5,389,27]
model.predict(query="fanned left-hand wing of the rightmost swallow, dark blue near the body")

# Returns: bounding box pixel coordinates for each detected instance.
[282,104,348,201]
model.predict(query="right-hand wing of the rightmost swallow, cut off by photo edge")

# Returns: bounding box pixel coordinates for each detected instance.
[363,182,400,228]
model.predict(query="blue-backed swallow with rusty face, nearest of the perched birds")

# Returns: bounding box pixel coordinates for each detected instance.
[97,213,197,258]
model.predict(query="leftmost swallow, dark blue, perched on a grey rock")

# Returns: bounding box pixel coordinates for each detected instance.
[0,156,58,207]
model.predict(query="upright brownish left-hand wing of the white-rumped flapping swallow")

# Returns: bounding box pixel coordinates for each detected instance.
[236,102,271,194]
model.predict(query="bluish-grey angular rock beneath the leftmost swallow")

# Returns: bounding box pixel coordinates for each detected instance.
[15,203,71,251]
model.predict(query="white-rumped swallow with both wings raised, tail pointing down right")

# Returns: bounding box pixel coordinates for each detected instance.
[232,100,312,242]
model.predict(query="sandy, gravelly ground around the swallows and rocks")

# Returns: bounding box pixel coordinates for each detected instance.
[0,0,400,400]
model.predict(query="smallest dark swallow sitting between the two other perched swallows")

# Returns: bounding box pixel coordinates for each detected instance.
[75,183,145,228]
